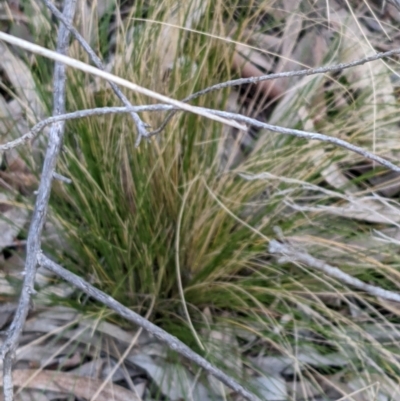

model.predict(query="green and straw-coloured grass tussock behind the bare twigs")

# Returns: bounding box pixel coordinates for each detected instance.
[3,0,400,396]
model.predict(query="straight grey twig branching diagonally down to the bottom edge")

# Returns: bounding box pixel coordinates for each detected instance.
[38,253,258,401]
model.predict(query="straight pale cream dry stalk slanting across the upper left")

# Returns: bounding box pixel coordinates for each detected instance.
[0,31,246,131]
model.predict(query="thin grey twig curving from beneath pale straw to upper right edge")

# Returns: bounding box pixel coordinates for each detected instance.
[150,45,400,135]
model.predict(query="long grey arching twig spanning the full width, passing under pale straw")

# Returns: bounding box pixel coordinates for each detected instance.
[0,104,400,172]
